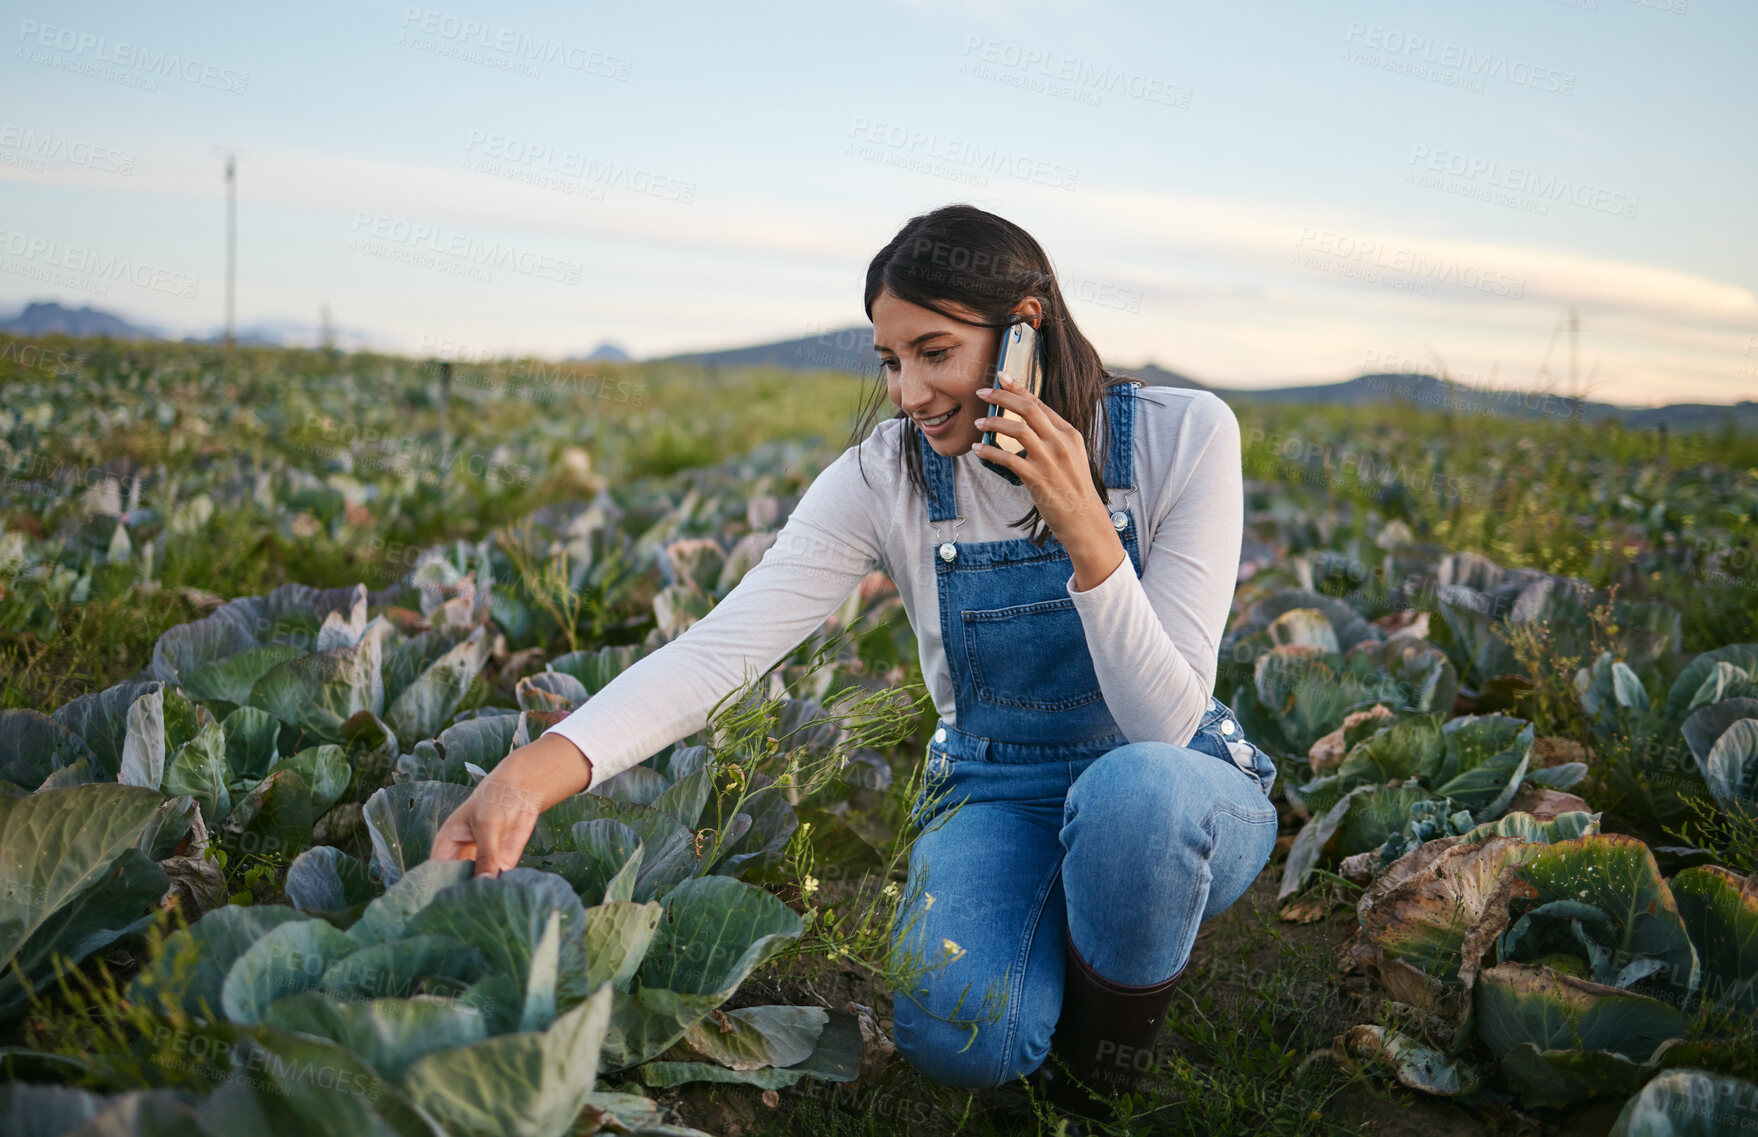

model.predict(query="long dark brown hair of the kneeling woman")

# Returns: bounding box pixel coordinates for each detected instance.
[847,204,1136,545]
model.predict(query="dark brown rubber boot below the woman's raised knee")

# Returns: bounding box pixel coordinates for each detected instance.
[1034,930,1185,1119]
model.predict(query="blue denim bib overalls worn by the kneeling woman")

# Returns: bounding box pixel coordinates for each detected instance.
[893,383,1276,1086]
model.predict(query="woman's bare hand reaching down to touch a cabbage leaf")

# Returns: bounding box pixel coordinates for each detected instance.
[431,735,592,877]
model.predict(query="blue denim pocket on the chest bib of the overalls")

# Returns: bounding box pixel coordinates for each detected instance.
[960,596,1104,712]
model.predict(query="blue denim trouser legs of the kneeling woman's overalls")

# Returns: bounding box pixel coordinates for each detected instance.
[893,721,1276,1088]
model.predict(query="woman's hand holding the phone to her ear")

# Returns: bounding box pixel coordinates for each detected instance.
[972,376,1113,548]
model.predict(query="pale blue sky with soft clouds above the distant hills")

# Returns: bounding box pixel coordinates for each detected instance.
[0,0,1758,404]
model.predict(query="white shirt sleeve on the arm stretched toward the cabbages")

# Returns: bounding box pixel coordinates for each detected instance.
[543,437,883,789]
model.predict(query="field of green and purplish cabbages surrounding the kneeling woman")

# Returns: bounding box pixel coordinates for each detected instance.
[0,339,1758,1137]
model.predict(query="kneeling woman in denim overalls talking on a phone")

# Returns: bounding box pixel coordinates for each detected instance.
[434,206,1276,1112]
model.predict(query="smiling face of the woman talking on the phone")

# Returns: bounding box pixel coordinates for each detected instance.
[874,292,1042,457]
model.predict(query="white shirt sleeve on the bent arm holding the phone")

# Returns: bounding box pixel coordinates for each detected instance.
[1067,395,1245,745]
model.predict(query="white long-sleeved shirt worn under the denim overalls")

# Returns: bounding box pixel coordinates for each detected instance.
[545,387,1245,787]
